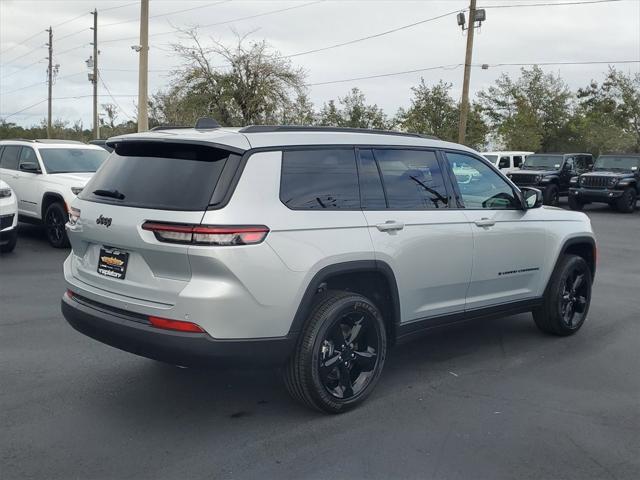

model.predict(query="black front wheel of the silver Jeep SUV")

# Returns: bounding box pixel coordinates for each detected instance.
[533,255,592,336]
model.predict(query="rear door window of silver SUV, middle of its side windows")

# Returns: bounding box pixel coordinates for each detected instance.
[373,149,448,210]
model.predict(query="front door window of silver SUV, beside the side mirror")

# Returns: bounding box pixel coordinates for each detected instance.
[447,153,520,210]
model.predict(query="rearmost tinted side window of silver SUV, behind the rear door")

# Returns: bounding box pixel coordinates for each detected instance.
[280,148,360,210]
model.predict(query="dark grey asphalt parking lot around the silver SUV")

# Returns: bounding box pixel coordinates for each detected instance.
[0,200,640,480]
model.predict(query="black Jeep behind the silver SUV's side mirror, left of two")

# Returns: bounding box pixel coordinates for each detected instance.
[507,153,593,206]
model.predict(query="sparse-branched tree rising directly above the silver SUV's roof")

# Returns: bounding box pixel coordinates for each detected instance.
[159,29,305,125]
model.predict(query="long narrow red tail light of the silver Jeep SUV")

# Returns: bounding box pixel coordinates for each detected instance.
[142,222,269,246]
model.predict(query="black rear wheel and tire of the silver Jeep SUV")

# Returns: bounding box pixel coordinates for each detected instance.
[284,291,387,413]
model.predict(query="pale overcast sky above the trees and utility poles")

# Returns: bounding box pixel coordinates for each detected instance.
[0,0,640,128]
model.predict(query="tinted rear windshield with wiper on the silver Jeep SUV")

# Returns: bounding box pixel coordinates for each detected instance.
[79,142,235,211]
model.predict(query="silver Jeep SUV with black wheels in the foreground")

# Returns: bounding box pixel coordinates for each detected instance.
[62,126,596,412]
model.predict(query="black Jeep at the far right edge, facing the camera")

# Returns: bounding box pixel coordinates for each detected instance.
[569,153,640,213]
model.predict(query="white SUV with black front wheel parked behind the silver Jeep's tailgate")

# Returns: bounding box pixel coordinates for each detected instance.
[0,140,109,248]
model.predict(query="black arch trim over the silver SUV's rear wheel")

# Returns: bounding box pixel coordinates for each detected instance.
[289,260,400,344]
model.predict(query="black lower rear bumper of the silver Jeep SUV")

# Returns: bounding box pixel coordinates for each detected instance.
[61,293,295,367]
